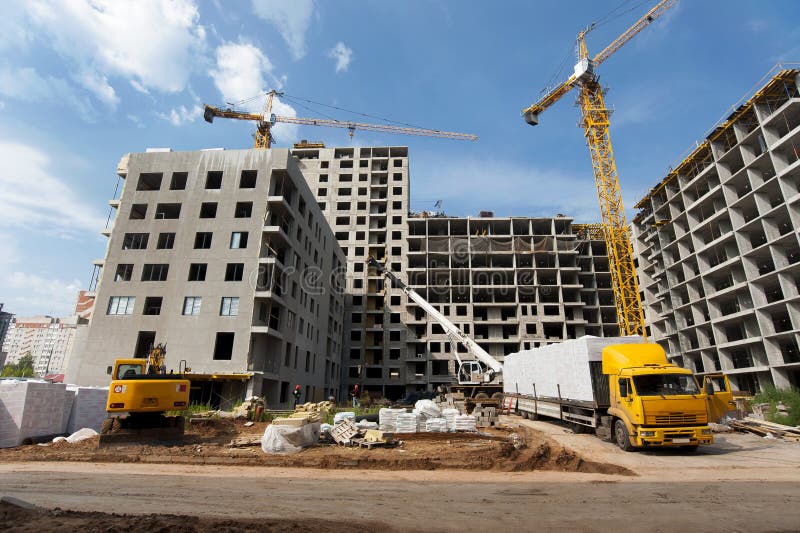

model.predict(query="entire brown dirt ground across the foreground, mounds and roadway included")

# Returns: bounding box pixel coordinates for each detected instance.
[0,417,800,533]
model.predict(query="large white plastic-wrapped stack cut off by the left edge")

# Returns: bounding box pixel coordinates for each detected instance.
[0,380,66,448]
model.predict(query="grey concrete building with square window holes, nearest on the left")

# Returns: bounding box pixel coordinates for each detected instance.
[72,149,344,406]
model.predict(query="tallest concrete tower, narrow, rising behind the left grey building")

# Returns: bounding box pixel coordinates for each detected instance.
[292,146,409,398]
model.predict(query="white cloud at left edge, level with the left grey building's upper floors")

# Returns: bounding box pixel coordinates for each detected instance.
[0,140,105,237]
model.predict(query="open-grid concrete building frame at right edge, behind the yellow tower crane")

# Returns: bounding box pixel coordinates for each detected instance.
[633,66,800,392]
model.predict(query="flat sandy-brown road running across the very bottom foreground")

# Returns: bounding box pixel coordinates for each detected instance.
[0,463,800,532]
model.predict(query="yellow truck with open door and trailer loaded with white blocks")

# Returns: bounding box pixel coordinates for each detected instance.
[503,336,734,451]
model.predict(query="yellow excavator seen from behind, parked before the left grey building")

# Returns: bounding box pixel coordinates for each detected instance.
[100,344,190,444]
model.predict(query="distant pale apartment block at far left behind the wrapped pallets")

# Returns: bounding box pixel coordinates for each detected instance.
[2,316,81,377]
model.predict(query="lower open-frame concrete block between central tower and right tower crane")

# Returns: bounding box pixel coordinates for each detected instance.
[400,217,619,390]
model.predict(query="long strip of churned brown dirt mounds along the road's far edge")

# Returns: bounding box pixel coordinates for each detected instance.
[0,419,634,475]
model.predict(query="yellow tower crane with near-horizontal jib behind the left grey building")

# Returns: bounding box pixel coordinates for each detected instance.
[203,89,478,148]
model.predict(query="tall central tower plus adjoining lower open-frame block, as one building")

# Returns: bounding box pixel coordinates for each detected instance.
[292,145,619,398]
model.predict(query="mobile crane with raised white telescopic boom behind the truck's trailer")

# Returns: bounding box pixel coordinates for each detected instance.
[367,257,503,398]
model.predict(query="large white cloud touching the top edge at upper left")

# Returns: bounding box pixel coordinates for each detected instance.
[22,0,206,107]
